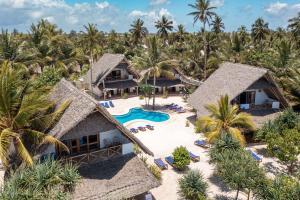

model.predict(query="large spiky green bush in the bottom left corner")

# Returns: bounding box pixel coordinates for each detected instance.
[0,160,80,200]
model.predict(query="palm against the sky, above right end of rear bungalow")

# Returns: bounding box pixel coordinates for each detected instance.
[129,18,148,45]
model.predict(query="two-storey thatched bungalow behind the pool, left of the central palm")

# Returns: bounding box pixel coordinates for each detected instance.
[82,53,139,99]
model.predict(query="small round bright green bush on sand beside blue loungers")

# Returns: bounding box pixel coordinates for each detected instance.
[173,146,191,170]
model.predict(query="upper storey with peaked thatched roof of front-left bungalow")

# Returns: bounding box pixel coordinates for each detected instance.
[50,79,153,155]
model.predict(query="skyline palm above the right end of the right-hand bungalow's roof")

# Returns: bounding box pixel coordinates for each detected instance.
[251,18,270,52]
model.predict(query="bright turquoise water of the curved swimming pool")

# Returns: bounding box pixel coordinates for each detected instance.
[114,108,170,124]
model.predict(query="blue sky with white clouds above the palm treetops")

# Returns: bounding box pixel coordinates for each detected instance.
[0,0,300,32]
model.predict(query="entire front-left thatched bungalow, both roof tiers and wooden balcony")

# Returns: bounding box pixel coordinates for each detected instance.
[44,79,159,199]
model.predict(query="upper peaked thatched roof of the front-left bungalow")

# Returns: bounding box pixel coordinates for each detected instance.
[50,79,153,155]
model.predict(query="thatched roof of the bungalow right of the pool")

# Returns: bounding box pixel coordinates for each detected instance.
[188,62,289,115]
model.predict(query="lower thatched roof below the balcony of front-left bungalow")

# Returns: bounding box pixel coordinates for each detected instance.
[73,154,160,200]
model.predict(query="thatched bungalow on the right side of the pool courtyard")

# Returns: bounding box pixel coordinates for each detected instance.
[188,62,289,125]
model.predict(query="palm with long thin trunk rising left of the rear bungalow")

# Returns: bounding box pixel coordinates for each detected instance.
[82,23,101,92]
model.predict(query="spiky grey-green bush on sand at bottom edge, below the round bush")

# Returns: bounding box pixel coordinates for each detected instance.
[178,170,208,200]
